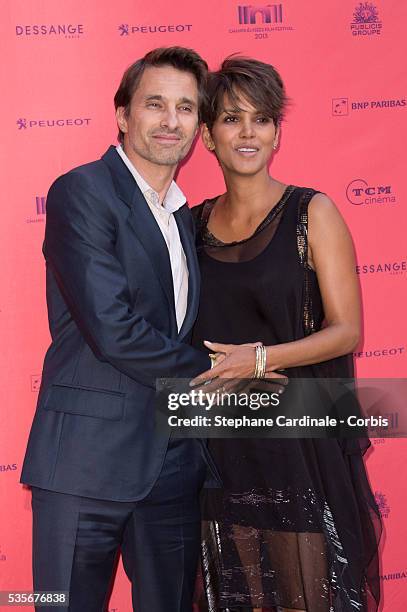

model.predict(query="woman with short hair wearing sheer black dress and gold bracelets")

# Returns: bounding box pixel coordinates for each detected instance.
[193,57,380,612]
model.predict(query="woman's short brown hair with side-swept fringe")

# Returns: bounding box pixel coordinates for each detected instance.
[204,55,288,130]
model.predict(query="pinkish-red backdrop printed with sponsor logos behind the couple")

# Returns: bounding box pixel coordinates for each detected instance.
[0,0,407,612]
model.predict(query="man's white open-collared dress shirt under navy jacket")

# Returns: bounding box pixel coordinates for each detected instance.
[116,145,188,331]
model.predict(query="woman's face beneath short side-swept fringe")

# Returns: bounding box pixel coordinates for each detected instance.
[203,96,279,175]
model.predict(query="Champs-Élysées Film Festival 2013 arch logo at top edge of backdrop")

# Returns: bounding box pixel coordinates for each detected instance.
[229,4,294,38]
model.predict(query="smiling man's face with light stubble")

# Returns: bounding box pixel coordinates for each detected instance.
[116,66,198,166]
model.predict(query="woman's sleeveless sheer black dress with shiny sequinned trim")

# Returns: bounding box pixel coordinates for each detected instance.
[193,186,381,612]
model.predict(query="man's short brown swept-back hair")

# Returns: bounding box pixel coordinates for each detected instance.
[114,47,208,142]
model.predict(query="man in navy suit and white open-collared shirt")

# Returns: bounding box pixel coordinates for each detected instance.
[21,47,223,612]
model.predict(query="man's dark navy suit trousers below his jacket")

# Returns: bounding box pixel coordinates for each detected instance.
[32,440,207,612]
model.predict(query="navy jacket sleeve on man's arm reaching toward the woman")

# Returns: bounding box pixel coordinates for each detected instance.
[44,172,210,387]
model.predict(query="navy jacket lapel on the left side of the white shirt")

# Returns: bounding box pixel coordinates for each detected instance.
[102,146,176,325]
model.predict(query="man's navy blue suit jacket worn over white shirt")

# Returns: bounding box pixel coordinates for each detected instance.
[21,146,214,501]
